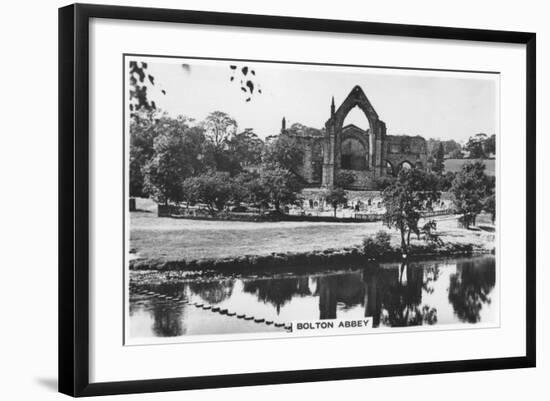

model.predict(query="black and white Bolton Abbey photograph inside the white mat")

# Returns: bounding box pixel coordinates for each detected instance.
[127,54,500,345]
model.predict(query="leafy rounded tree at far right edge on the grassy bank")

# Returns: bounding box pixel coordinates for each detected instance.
[451,161,494,228]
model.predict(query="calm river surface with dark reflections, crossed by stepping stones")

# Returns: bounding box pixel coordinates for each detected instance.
[130,256,498,337]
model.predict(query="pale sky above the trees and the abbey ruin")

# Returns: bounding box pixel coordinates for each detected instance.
[135,58,499,142]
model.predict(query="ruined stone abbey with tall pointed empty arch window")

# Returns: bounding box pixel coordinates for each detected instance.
[281,86,428,190]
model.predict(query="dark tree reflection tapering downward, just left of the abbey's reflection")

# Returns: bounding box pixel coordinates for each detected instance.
[243,276,311,314]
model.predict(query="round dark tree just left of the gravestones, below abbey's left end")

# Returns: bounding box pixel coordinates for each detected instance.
[260,168,303,212]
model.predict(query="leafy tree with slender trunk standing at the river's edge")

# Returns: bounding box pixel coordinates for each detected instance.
[382,169,441,254]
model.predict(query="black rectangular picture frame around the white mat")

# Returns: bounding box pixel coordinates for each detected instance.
[59,4,536,396]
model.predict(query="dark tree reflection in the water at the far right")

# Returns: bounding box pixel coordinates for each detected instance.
[449,258,495,323]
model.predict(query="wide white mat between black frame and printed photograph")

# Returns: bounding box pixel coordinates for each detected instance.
[89,20,526,382]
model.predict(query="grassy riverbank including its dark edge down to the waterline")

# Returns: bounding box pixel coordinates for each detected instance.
[129,212,495,270]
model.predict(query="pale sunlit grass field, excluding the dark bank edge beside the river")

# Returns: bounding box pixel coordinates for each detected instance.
[130,211,494,260]
